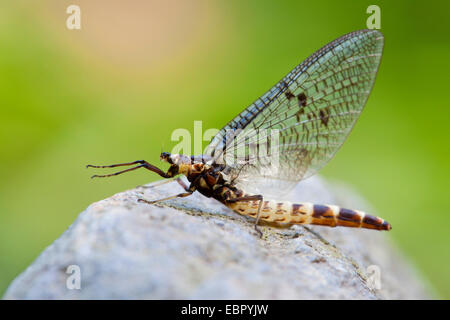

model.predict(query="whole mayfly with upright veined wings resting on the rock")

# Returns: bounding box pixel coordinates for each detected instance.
[87,30,391,235]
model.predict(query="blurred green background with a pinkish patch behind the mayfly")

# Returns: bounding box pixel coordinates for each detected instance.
[0,0,450,298]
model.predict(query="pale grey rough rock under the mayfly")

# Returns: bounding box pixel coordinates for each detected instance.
[3,177,430,299]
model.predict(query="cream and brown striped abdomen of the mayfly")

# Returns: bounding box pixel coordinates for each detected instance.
[226,200,391,230]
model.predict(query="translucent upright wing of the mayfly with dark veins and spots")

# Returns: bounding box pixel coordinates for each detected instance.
[205,30,384,193]
